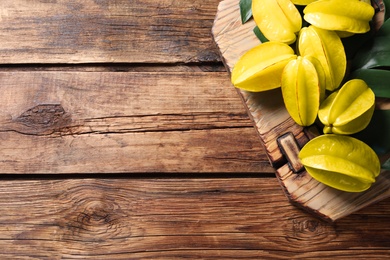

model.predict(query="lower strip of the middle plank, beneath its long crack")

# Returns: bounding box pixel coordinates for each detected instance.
[0,127,273,173]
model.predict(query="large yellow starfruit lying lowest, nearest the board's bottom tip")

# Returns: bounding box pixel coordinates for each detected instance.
[299,134,381,192]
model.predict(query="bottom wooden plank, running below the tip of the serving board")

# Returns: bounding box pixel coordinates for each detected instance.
[0,178,390,259]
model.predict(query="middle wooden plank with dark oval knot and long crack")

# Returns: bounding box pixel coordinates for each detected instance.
[0,72,273,173]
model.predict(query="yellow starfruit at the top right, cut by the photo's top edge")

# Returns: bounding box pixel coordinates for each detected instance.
[303,0,375,33]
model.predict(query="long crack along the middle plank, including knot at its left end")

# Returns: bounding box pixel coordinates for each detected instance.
[0,110,253,137]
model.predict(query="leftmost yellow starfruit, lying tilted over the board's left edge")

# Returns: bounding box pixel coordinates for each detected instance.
[231,41,296,92]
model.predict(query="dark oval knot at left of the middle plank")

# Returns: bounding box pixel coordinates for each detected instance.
[14,104,71,134]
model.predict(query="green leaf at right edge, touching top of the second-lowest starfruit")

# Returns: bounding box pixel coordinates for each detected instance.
[349,69,390,98]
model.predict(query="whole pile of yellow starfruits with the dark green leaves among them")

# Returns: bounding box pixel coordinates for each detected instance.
[231,0,390,192]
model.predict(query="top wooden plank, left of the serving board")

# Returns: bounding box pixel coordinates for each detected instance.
[0,0,220,64]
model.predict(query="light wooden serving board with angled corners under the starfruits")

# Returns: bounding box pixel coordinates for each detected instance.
[212,0,390,222]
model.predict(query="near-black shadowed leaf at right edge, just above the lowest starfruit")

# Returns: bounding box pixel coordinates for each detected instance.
[353,110,390,155]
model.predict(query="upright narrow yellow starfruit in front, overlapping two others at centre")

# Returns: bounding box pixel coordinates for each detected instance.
[282,56,321,126]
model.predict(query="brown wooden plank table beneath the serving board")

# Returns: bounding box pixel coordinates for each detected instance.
[0,0,390,259]
